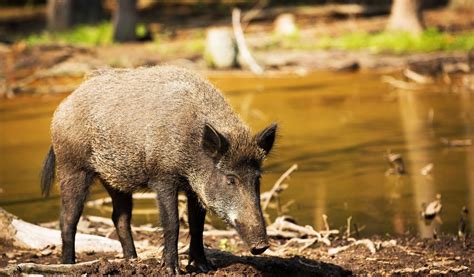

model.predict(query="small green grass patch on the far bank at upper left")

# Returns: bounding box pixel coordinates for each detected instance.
[23,22,112,46]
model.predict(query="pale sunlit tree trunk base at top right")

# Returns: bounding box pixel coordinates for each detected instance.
[387,0,425,34]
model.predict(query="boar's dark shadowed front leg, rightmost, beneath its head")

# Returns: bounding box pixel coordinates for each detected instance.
[187,191,213,272]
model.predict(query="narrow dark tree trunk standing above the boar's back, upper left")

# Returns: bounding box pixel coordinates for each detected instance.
[114,0,137,42]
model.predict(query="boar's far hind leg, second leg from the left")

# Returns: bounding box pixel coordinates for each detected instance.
[102,181,137,258]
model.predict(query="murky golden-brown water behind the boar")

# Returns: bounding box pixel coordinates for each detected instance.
[0,73,474,236]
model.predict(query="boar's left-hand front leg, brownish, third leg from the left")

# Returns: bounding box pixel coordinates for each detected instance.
[151,182,179,274]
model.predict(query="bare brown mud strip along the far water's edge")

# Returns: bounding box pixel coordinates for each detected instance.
[0,41,474,98]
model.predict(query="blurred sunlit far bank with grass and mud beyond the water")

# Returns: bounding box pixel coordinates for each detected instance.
[0,7,474,97]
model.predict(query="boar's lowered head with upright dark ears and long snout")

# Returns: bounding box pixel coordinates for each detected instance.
[198,124,277,255]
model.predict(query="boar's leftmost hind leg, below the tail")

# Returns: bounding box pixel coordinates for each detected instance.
[58,167,94,264]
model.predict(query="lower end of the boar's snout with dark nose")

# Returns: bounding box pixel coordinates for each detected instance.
[234,220,270,255]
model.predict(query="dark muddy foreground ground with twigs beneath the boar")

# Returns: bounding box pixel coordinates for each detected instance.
[0,216,474,276]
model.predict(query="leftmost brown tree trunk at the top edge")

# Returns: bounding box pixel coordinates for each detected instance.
[47,0,73,31]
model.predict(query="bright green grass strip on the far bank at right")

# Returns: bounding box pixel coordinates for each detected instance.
[281,29,474,53]
